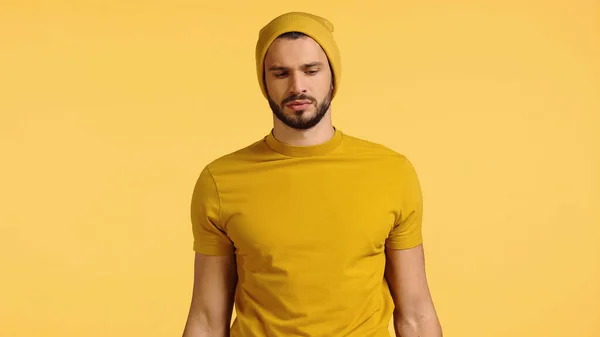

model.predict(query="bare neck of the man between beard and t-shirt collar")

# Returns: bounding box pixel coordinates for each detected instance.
[273,111,335,146]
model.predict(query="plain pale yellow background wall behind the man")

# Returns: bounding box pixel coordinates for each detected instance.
[0,0,600,337]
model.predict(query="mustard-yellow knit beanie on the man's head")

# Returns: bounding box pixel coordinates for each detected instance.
[256,12,342,98]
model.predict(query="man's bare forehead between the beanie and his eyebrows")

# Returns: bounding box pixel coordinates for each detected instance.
[265,37,327,68]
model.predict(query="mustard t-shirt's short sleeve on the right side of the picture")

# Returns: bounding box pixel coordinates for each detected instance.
[386,158,423,249]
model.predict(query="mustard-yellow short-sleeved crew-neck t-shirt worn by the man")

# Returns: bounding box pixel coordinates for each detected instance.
[192,128,422,337]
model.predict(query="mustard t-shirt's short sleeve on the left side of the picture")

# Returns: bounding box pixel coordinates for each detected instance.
[190,166,233,255]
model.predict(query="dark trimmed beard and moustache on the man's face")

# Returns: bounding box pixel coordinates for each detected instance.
[268,88,333,130]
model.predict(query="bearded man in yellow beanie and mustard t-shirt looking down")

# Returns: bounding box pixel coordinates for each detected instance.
[183,12,442,337]
